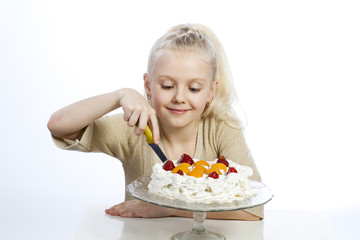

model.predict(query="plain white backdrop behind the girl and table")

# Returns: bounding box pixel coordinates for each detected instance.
[0,0,360,239]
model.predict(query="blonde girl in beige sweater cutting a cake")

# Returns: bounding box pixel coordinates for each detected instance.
[48,25,263,220]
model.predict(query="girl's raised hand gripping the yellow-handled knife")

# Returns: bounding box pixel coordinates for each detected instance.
[119,88,160,144]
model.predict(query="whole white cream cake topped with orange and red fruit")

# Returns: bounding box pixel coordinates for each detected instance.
[148,154,254,203]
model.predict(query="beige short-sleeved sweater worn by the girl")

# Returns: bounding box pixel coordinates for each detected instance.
[53,114,263,218]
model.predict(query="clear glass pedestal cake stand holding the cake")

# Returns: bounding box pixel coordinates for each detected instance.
[127,177,273,240]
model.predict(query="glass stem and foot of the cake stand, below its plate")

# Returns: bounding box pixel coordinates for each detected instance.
[171,212,226,240]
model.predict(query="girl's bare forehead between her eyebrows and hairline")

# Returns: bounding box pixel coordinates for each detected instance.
[152,51,212,80]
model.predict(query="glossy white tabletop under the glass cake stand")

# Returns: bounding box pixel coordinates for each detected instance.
[75,205,346,240]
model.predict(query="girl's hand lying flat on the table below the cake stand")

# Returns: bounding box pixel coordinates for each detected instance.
[105,200,171,218]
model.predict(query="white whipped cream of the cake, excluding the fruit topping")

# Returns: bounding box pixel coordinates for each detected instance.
[148,159,254,203]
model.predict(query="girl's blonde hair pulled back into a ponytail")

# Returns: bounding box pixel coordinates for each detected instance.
[147,24,241,128]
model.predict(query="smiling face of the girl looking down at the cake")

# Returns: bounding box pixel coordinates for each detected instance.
[144,51,216,128]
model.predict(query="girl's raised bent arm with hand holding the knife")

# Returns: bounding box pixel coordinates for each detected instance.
[48,89,159,143]
